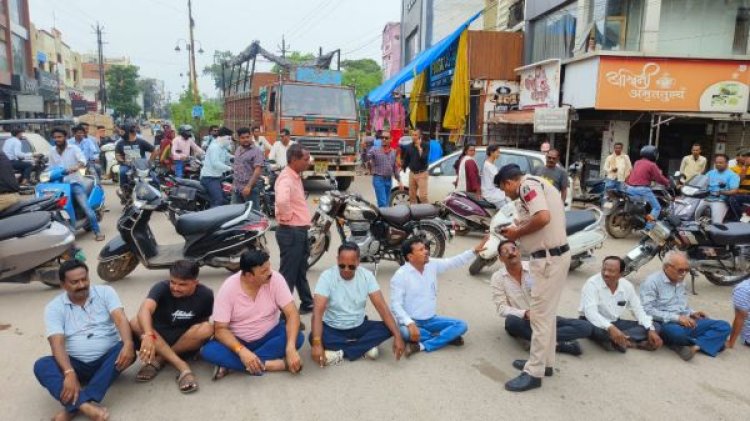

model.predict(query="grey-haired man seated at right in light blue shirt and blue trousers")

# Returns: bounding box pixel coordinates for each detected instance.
[640,250,731,361]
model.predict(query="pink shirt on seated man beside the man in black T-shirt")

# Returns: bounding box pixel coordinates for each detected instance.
[213,271,293,342]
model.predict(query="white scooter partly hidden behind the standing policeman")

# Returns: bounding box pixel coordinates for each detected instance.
[469,202,607,275]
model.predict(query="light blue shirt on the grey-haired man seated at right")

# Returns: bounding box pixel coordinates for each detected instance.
[640,271,694,323]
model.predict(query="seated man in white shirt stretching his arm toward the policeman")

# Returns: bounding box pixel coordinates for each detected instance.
[391,237,487,357]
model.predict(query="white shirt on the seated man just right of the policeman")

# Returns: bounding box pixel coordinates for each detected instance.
[579,274,653,330]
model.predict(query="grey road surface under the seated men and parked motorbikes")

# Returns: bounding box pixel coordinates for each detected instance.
[0,177,750,420]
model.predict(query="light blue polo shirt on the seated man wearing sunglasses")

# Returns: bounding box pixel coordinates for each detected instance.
[315,266,380,329]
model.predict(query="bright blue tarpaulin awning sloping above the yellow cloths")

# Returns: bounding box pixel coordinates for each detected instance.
[367,12,482,104]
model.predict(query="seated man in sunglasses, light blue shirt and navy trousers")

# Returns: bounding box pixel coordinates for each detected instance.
[310,242,404,367]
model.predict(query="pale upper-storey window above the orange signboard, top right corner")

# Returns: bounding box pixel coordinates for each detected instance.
[658,0,750,57]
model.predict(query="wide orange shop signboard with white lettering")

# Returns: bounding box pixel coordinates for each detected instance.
[596,56,750,113]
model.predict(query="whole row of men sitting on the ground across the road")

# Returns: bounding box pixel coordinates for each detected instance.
[34,239,750,420]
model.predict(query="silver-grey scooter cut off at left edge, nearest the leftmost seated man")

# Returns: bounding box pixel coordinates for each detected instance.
[0,211,75,287]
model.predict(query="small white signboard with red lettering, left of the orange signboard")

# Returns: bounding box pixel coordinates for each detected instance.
[516,59,560,110]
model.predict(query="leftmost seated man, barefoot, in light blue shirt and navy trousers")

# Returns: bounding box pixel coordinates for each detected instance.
[34,260,135,421]
